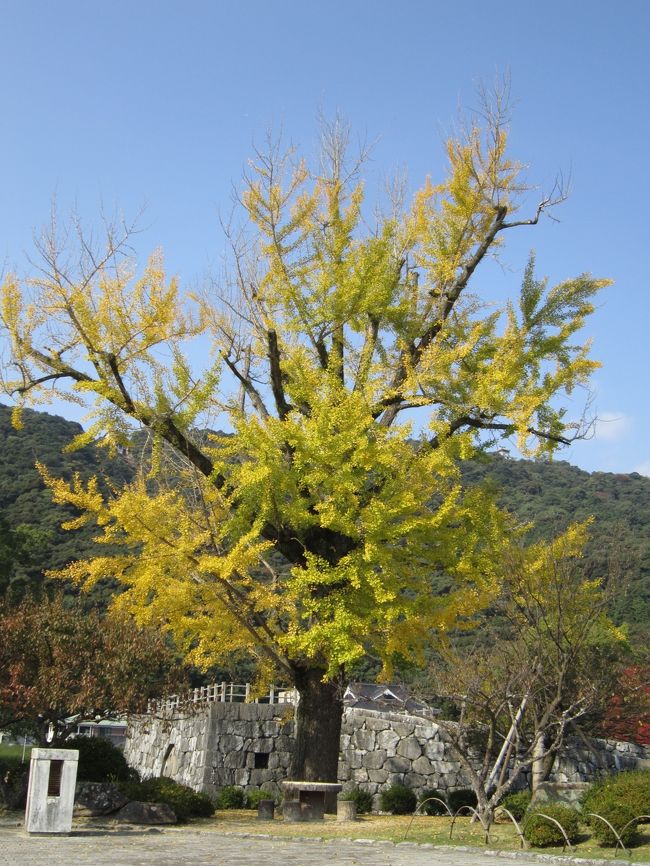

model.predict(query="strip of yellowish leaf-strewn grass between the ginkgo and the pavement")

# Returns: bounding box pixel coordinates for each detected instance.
[193,809,650,863]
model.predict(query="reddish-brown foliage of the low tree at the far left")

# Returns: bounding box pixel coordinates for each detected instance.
[0,596,178,730]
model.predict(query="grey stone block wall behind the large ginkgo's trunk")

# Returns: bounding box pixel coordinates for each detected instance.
[125,703,650,807]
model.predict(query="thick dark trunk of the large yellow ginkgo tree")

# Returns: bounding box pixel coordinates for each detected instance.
[291,668,343,782]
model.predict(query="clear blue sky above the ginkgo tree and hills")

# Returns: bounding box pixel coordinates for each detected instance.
[0,0,650,475]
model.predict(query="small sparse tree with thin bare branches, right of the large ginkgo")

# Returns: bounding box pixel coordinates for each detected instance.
[412,523,626,826]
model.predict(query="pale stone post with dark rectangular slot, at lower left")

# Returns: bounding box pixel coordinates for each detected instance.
[25,749,79,833]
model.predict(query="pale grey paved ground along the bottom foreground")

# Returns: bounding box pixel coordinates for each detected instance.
[0,827,621,866]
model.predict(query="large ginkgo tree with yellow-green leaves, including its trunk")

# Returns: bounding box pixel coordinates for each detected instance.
[2,108,605,781]
